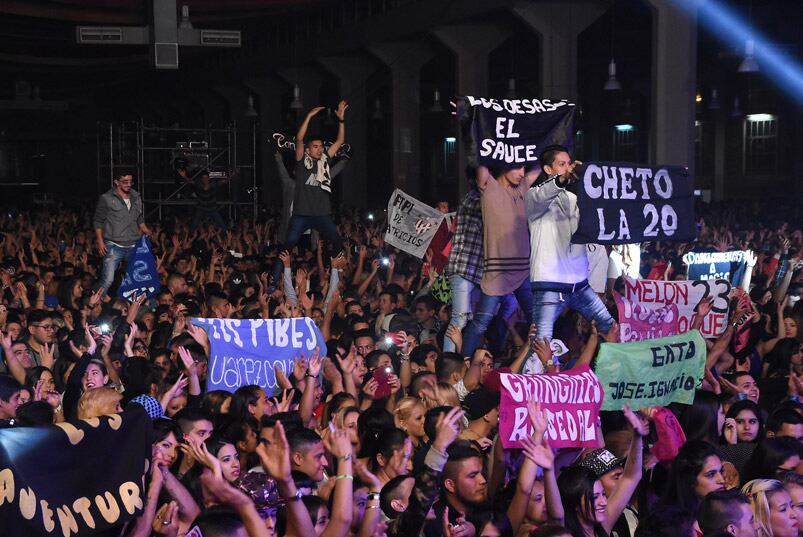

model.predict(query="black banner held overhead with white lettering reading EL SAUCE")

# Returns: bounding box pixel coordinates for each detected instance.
[457,96,575,167]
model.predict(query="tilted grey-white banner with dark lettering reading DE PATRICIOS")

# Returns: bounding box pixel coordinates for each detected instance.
[385,188,445,258]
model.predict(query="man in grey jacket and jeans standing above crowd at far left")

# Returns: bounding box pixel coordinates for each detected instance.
[92,169,151,290]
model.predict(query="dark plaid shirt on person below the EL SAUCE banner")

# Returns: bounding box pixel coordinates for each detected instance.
[445,190,483,285]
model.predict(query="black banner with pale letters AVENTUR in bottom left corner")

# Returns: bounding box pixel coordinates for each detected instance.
[0,409,151,537]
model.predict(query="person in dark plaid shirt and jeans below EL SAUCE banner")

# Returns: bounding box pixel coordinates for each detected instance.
[443,179,483,352]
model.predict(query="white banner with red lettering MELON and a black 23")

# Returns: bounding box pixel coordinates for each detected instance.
[622,276,731,341]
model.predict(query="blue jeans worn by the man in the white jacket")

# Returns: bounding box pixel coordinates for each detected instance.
[532,285,613,339]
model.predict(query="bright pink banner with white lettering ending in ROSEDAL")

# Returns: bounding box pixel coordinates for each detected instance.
[499,366,602,449]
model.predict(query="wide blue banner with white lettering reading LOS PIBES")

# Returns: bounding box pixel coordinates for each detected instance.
[191,317,326,393]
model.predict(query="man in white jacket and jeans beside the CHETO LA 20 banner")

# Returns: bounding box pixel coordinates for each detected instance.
[525,145,614,372]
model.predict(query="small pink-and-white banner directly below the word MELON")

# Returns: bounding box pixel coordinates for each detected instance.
[613,292,678,343]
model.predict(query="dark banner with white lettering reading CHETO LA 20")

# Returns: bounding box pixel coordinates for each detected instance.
[572,162,697,244]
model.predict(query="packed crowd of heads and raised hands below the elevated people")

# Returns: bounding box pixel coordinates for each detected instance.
[0,176,803,537]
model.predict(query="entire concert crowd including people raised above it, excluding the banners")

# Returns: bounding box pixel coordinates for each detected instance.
[0,103,803,537]
